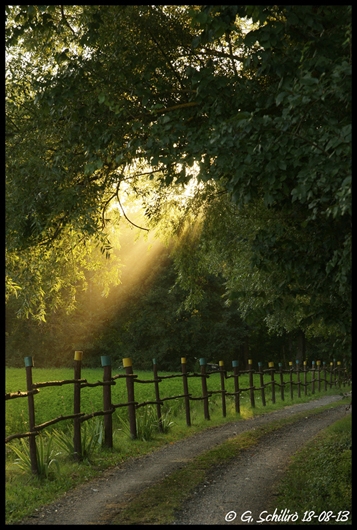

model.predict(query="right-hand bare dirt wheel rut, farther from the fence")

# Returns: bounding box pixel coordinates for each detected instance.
[173,406,346,525]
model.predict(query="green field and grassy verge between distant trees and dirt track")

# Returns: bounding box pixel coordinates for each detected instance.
[5,368,350,523]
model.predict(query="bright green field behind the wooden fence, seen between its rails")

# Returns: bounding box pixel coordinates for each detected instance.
[6,368,340,436]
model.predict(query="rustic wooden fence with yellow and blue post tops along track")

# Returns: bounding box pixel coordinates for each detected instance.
[5,351,350,474]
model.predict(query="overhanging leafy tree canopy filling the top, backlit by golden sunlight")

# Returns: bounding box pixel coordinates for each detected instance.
[6,5,352,356]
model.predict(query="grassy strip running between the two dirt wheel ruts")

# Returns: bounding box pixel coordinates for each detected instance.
[105,402,348,525]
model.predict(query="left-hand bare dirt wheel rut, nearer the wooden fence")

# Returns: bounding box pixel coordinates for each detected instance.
[16,395,344,525]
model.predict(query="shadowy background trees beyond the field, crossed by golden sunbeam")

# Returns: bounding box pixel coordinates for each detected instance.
[6,239,249,370]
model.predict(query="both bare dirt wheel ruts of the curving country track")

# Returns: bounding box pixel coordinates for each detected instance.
[18,396,346,525]
